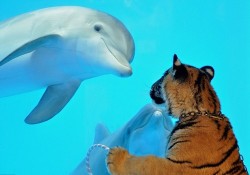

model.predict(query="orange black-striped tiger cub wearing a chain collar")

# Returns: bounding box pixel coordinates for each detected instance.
[107,55,248,175]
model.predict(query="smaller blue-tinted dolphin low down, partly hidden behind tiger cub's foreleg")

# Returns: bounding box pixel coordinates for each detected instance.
[71,104,173,175]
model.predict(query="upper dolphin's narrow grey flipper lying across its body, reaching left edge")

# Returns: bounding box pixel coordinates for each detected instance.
[0,34,60,66]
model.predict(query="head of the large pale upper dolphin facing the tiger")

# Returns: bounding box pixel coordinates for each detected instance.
[72,7,135,76]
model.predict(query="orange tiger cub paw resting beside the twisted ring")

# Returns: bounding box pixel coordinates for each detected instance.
[106,147,130,175]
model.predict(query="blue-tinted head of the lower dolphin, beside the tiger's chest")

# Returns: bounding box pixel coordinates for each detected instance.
[126,104,173,157]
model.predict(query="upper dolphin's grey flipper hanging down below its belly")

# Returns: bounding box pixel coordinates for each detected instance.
[25,81,81,124]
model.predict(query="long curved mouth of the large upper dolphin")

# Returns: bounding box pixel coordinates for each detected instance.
[101,38,132,75]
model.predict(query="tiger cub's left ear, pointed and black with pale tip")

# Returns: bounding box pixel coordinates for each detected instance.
[172,54,188,81]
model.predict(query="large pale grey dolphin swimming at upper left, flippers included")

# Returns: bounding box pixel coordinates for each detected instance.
[0,6,134,124]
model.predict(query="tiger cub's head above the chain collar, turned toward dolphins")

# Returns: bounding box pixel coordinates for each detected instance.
[150,55,220,117]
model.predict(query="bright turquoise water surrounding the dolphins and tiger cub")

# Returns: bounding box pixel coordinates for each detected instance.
[0,0,250,175]
